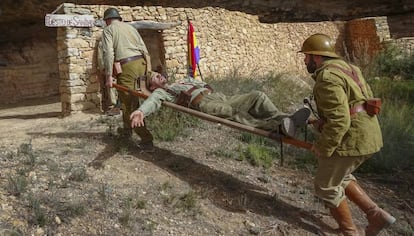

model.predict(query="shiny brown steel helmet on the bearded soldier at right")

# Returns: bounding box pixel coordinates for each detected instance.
[299,34,339,58]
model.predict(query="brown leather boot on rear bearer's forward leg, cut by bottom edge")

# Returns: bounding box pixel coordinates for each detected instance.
[329,199,359,236]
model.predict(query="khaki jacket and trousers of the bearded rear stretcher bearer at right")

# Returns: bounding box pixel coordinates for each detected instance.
[313,59,383,207]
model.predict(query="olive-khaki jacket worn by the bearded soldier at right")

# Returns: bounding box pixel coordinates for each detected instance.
[313,59,383,157]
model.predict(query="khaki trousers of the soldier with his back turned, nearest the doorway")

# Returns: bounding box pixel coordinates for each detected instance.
[117,58,153,143]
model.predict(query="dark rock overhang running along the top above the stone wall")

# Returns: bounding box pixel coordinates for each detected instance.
[0,0,414,28]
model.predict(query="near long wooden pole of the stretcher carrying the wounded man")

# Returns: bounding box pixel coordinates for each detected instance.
[113,84,312,149]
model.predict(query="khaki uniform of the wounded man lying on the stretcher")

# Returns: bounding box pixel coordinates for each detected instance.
[139,78,288,131]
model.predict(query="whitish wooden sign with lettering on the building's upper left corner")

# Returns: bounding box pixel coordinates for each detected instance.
[45,14,95,27]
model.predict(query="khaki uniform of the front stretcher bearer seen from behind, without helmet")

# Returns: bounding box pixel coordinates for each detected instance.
[102,20,153,143]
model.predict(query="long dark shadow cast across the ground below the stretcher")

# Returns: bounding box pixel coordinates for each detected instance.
[89,139,335,234]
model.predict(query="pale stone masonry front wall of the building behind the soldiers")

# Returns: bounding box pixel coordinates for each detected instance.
[57,4,344,114]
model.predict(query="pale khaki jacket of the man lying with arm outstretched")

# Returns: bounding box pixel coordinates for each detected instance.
[138,78,207,117]
